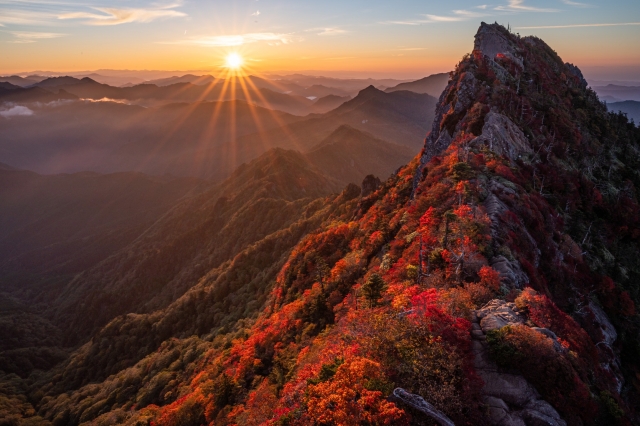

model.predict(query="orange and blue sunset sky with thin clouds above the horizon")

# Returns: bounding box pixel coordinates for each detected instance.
[0,0,640,81]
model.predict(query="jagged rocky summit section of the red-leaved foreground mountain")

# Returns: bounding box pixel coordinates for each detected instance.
[415,22,604,175]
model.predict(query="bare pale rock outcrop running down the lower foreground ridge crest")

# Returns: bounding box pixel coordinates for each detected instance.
[471,299,566,426]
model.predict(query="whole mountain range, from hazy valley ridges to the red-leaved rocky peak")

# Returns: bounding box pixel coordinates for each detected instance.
[0,23,640,426]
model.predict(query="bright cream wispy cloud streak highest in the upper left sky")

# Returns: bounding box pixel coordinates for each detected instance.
[58,3,187,25]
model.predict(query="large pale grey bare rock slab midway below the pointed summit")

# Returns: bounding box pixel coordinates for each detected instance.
[471,112,533,161]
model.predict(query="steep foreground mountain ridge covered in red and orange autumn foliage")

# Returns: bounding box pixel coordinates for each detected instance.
[10,24,640,425]
